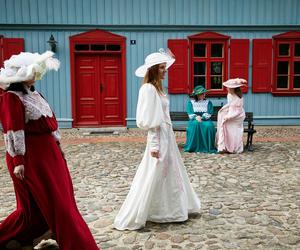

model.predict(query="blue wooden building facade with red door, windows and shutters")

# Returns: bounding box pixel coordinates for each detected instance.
[0,0,300,127]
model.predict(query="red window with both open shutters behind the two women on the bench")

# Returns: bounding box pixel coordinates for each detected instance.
[168,31,249,96]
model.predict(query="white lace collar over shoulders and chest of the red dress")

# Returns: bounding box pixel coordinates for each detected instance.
[9,91,53,123]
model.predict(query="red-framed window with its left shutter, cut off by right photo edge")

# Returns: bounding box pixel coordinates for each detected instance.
[252,31,300,96]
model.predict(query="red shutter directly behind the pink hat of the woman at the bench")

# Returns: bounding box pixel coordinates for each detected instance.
[230,39,249,93]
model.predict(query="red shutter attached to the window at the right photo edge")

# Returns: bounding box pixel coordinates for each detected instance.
[252,39,272,93]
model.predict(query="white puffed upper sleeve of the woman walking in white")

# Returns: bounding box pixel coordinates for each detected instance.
[136,83,164,130]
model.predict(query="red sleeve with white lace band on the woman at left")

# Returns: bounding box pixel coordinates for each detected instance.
[0,92,25,166]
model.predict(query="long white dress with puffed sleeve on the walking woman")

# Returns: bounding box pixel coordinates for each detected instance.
[114,83,200,230]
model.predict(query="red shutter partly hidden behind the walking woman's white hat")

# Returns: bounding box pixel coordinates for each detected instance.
[168,39,189,94]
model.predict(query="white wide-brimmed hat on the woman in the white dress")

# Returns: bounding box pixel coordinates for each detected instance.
[135,49,175,77]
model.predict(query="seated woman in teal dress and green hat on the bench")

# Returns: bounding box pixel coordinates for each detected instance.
[184,86,217,153]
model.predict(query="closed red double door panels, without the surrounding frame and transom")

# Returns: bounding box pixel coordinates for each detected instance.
[74,54,123,127]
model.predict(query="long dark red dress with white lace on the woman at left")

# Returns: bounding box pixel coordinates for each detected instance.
[0,91,99,250]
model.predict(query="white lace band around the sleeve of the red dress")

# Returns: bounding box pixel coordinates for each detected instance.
[4,130,25,157]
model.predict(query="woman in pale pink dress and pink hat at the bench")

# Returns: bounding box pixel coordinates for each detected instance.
[216,78,247,153]
